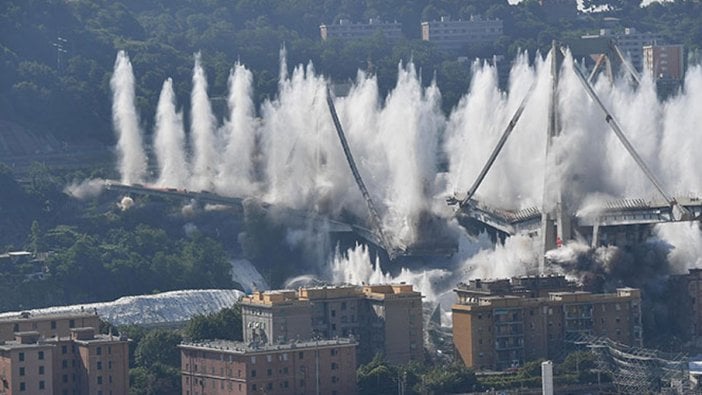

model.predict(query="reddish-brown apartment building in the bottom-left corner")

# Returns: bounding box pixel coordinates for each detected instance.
[0,313,129,395]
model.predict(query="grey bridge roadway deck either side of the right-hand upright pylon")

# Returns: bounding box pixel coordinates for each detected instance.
[456,193,702,245]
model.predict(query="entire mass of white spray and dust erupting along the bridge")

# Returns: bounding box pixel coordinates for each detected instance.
[106,49,702,284]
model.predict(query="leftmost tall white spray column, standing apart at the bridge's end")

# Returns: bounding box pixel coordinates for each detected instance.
[110,51,147,184]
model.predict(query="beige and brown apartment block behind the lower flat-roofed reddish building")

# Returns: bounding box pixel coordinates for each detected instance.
[241,284,424,363]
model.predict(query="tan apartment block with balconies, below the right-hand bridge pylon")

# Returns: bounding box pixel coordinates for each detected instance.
[452,279,641,370]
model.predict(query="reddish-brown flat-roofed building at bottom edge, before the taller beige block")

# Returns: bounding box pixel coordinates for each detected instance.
[179,339,357,395]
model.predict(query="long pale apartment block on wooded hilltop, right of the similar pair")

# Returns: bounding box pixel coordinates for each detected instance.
[422,16,502,52]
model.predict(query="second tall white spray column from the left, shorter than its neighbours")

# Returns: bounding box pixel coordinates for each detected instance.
[154,78,189,188]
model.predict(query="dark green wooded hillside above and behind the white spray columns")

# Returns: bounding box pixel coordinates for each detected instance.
[0,0,702,144]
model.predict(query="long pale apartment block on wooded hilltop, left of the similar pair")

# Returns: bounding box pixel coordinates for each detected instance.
[319,18,403,41]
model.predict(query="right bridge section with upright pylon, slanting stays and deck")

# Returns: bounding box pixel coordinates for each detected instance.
[447,41,702,273]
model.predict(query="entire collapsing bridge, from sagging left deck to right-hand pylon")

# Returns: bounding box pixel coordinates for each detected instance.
[105,42,702,262]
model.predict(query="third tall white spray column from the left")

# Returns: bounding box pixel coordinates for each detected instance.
[190,52,219,190]
